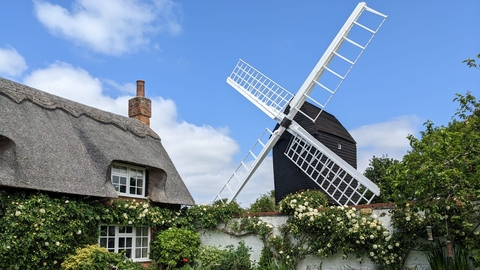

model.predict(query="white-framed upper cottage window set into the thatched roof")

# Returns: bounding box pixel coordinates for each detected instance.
[112,164,145,197]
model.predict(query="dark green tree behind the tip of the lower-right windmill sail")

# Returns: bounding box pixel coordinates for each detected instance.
[363,155,399,203]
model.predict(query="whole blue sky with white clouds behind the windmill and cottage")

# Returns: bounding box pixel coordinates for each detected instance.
[0,0,480,207]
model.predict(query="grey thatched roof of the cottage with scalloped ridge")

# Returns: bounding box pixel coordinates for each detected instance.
[0,78,194,205]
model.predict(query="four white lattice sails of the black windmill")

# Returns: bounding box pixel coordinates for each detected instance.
[214,2,387,205]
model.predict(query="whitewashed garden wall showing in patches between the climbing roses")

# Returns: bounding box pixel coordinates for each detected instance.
[200,207,429,270]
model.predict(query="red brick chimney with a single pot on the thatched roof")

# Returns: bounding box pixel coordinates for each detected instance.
[128,80,152,126]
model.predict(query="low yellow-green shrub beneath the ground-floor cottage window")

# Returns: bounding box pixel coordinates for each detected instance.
[62,245,144,270]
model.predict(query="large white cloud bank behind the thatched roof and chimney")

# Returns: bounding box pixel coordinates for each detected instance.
[24,62,246,206]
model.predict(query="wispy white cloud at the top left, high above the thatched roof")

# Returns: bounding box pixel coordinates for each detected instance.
[34,0,182,55]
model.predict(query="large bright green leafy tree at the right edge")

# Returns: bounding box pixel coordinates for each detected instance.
[387,92,480,262]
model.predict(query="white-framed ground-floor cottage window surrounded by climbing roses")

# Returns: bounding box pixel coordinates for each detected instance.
[98,225,150,262]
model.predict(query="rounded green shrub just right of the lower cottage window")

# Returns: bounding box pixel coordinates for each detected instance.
[150,227,200,269]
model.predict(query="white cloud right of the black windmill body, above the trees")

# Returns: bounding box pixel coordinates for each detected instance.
[350,115,420,172]
